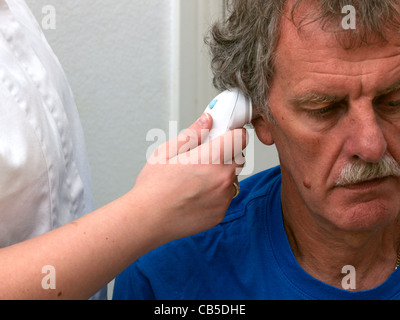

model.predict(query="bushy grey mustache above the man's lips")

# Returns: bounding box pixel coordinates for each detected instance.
[335,155,400,186]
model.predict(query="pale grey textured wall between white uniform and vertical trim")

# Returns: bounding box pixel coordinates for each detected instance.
[27,0,173,206]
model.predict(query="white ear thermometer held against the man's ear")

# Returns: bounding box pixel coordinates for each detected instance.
[204,88,253,142]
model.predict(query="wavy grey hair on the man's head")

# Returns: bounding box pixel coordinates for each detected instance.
[206,0,400,119]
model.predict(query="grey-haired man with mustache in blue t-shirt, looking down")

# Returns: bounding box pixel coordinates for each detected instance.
[114,0,400,299]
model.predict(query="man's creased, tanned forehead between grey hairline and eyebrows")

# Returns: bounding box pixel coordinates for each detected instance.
[273,2,400,103]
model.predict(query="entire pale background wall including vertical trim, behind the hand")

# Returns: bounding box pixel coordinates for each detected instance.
[26,0,277,207]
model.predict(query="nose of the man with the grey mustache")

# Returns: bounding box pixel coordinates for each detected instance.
[346,103,387,162]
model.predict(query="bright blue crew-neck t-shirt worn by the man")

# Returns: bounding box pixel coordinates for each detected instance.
[113,167,400,300]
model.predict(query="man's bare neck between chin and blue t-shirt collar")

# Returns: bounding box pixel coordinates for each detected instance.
[282,188,400,291]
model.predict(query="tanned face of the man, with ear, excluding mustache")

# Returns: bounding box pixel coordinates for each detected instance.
[255,14,400,231]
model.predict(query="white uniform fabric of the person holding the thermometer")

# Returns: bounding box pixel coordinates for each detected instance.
[0,0,105,298]
